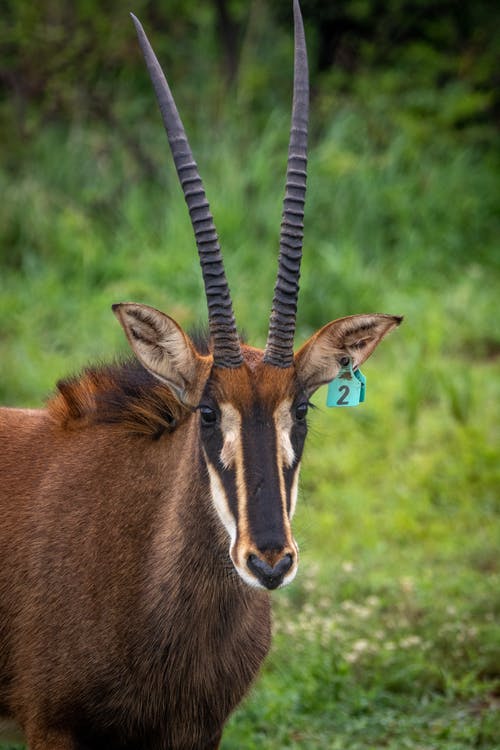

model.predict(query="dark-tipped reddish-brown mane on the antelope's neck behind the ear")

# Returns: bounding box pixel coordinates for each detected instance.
[47,359,190,439]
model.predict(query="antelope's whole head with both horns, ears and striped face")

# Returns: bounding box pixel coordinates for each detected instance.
[113,0,401,589]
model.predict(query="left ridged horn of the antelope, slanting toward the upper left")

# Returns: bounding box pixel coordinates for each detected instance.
[130,13,243,368]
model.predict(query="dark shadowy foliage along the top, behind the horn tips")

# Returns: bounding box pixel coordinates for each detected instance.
[0,0,500,150]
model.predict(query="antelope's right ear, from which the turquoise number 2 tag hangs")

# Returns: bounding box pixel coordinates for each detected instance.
[295,315,403,396]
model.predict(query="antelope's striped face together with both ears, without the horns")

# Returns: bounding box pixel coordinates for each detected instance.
[114,303,401,589]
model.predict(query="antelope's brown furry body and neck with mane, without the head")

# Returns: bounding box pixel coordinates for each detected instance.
[0,352,270,750]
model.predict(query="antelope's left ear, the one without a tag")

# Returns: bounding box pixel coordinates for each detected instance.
[113,302,212,406]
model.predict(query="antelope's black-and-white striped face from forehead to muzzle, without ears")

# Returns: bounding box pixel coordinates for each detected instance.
[198,362,308,589]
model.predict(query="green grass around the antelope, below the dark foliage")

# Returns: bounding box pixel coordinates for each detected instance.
[0,92,500,750]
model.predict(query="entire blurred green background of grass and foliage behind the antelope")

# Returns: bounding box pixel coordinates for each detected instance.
[0,0,500,750]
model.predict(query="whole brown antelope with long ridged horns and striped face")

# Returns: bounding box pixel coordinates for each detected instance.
[0,0,401,750]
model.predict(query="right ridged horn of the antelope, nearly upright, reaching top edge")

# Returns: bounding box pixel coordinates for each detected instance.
[264,0,309,367]
